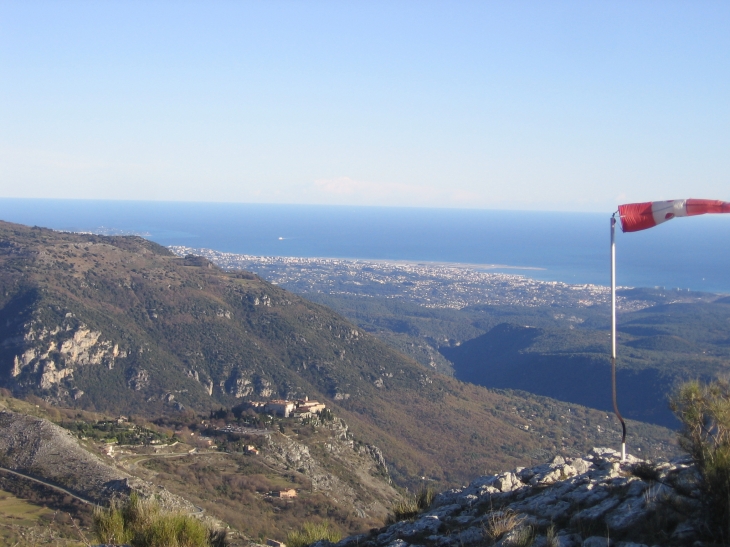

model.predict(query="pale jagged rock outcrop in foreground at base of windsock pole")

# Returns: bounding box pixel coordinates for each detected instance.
[322,448,706,547]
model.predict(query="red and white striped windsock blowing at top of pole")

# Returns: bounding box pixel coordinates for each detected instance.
[618,199,730,232]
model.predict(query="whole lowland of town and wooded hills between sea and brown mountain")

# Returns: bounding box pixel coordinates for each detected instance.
[174,248,730,428]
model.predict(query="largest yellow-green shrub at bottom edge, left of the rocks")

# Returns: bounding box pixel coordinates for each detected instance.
[94,493,226,547]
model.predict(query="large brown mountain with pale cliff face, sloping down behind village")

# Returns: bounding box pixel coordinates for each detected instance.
[0,223,670,484]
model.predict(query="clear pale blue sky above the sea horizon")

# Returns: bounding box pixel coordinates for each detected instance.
[0,0,730,211]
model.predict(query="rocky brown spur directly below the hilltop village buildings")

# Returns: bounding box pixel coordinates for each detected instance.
[126,419,400,540]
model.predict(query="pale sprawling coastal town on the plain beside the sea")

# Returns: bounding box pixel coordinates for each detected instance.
[170,246,660,311]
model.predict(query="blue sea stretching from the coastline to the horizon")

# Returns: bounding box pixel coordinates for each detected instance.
[0,199,730,293]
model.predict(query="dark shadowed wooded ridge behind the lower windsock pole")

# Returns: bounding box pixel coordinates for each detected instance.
[439,298,730,427]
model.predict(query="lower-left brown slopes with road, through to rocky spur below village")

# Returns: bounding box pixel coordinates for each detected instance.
[0,394,400,539]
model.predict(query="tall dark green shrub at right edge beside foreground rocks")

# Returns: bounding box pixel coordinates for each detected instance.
[670,378,730,542]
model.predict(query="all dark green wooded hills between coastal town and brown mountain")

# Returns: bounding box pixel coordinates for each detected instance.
[306,289,730,428]
